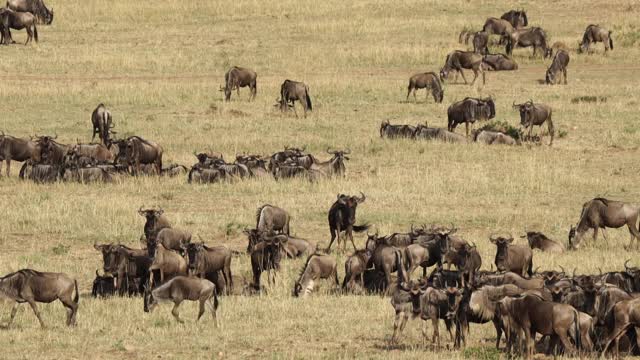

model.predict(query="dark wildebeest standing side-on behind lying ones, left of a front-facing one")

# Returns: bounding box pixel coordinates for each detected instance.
[447,97,496,137]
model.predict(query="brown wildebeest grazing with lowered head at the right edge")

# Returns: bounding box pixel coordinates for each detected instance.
[569,198,640,250]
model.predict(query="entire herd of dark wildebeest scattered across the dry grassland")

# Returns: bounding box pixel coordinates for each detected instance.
[0,0,640,357]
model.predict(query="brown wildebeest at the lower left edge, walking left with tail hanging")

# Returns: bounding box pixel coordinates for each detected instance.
[0,269,80,328]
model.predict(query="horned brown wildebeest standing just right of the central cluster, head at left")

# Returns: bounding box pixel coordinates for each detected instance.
[489,236,533,276]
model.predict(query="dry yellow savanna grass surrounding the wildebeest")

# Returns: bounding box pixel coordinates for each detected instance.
[0,0,640,359]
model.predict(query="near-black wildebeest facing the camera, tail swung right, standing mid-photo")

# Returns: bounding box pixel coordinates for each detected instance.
[327,192,369,252]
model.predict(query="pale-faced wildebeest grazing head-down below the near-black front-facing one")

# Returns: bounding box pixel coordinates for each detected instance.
[293,253,340,298]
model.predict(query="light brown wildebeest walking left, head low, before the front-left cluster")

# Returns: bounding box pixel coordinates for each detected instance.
[144,276,219,327]
